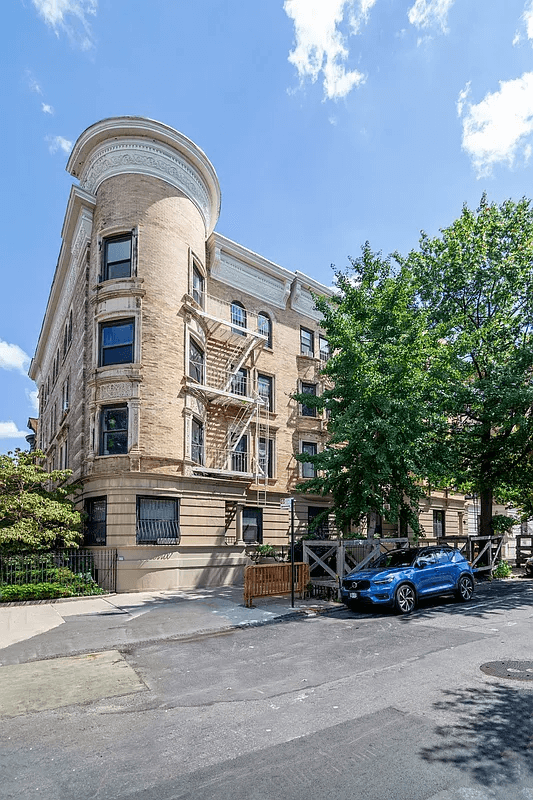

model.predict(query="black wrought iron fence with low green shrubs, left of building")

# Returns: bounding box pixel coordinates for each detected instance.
[0,548,117,592]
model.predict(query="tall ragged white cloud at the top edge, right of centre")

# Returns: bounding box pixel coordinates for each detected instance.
[283,0,377,100]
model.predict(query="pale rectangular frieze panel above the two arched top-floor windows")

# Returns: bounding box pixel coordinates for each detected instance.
[211,253,290,308]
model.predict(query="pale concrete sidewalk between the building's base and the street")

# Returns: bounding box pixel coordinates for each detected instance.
[0,586,342,650]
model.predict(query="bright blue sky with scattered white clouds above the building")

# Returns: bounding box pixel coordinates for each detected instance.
[0,0,533,452]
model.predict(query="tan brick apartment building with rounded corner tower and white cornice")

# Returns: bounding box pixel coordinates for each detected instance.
[30,117,329,591]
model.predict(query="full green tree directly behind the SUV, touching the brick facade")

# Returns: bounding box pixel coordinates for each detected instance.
[297,244,446,534]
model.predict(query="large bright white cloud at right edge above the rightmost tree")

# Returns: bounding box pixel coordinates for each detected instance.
[458,72,533,178]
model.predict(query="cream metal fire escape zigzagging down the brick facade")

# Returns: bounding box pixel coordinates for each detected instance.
[184,292,270,503]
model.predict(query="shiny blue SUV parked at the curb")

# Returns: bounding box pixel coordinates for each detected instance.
[341,547,474,614]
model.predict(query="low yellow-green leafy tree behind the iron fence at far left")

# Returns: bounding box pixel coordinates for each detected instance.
[0,450,83,551]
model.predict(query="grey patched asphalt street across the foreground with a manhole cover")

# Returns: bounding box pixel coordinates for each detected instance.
[0,580,533,800]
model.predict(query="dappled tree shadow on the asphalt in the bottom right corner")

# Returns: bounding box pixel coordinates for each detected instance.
[420,683,533,788]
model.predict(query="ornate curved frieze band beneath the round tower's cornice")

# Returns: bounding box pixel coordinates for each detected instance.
[80,138,211,230]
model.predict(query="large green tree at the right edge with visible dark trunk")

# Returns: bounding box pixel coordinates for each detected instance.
[404,196,533,535]
